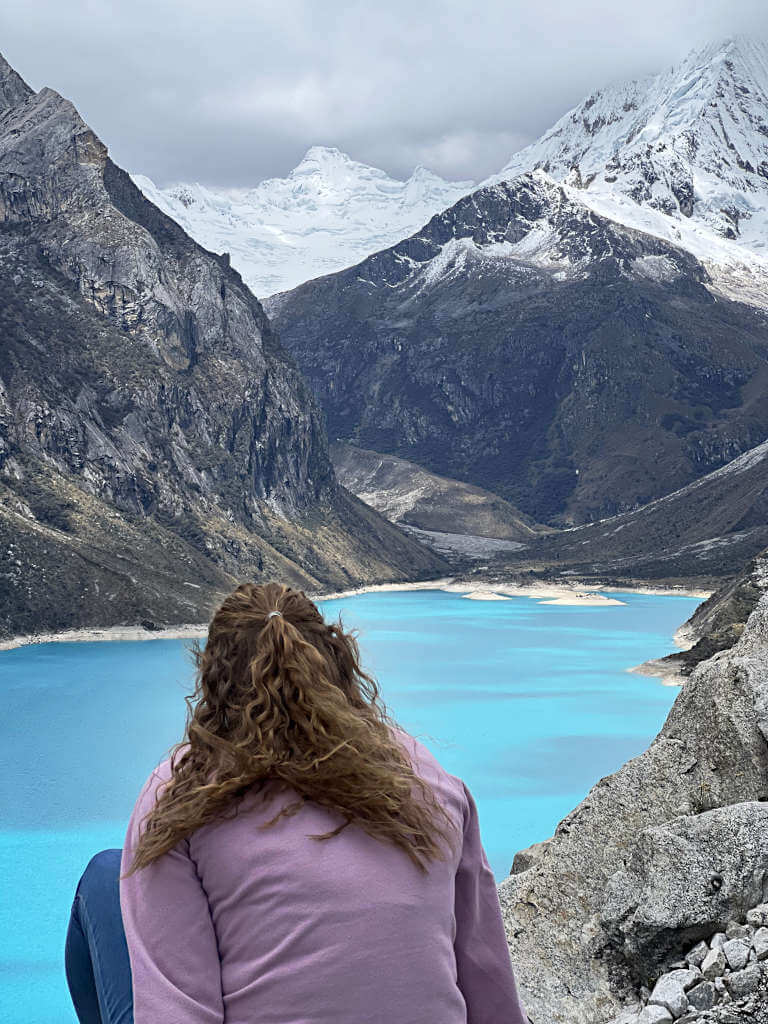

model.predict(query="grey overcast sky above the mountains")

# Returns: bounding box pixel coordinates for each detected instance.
[0,0,768,185]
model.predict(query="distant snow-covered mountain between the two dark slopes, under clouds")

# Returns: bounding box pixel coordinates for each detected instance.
[133,146,473,296]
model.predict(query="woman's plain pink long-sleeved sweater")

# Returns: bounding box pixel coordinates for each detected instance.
[120,733,527,1024]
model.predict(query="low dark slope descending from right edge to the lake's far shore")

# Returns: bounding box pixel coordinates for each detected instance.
[496,441,768,589]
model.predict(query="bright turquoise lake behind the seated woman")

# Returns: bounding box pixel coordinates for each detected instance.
[0,591,699,1024]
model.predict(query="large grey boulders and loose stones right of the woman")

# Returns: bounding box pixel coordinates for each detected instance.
[500,591,768,1024]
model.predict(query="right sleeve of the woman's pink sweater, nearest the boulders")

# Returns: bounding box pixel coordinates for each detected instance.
[454,782,528,1024]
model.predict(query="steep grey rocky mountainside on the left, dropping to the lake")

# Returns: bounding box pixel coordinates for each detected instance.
[0,54,443,635]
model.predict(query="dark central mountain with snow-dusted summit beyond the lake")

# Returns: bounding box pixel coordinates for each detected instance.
[266,172,768,524]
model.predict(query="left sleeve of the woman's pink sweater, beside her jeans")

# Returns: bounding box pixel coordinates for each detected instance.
[120,763,224,1024]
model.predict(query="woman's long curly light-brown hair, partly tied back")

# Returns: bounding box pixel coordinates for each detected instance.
[126,583,456,874]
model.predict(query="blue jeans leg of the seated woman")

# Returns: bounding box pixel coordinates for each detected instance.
[65,850,133,1024]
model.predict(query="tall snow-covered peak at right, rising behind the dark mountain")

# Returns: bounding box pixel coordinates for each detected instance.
[492,37,768,251]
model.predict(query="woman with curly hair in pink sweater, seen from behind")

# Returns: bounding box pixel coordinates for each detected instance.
[67,583,526,1024]
